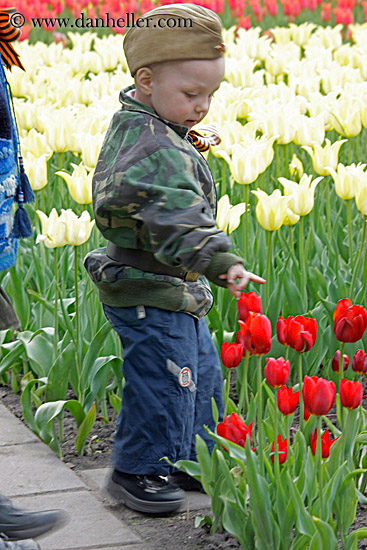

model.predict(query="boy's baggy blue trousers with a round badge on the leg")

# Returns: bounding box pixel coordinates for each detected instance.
[103,304,223,475]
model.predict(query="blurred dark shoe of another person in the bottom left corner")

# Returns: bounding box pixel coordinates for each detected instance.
[0,495,66,550]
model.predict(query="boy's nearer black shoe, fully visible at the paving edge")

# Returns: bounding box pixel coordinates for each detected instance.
[106,470,185,514]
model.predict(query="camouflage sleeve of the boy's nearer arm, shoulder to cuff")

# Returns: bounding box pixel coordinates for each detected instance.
[93,112,246,286]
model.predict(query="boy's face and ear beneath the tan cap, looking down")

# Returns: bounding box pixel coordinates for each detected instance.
[136,57,224,128]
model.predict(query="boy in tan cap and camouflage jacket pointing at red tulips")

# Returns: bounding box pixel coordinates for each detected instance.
[85,4,264,514]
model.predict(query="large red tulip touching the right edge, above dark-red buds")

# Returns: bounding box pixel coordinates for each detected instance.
[333,298,367,342]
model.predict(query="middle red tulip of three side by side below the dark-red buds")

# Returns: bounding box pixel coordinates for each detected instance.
[302,376,335,416]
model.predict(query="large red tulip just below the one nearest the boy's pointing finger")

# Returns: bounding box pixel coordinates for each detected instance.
[238,311,271,355]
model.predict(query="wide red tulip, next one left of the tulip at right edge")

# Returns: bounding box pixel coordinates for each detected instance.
[276,315,317,353]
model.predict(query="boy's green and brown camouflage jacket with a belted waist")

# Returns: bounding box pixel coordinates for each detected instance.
[84,86,242,318]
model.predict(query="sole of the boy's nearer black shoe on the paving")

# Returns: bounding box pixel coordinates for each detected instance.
[105,477,185,514]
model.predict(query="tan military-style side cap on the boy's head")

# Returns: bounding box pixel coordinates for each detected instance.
[124,4,225,76]
